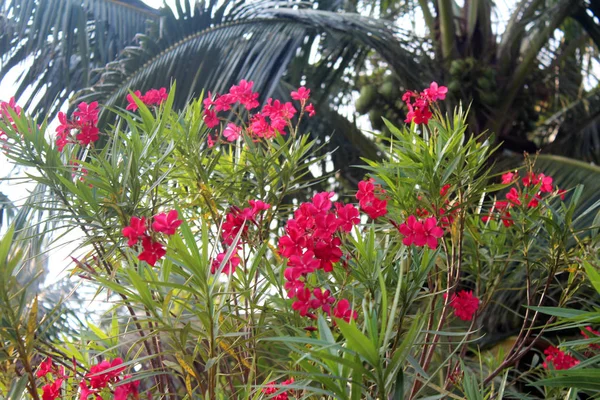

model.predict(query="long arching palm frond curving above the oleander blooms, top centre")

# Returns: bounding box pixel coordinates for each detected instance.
[82,7,418,113]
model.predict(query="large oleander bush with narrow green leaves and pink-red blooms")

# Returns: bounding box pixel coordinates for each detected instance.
[0,81,599,400]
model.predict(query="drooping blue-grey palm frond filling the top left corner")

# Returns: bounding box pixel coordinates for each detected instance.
[0,0,159,115]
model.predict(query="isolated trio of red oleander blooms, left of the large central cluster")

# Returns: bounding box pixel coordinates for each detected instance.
[122,210,183,266]
